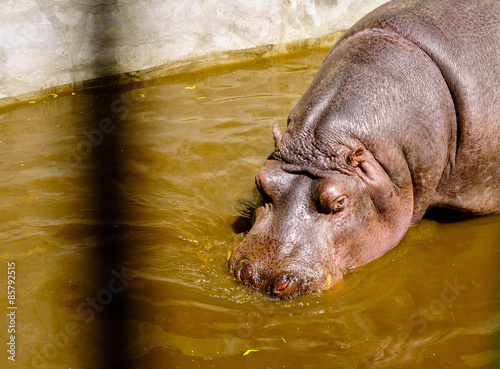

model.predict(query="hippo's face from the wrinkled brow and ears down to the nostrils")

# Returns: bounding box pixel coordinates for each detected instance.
[229,110,411,299]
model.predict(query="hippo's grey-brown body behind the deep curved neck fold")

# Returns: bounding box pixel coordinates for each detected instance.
[336,0,500,214]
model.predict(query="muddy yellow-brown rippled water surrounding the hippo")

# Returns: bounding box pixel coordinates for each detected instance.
[0,49,500,369]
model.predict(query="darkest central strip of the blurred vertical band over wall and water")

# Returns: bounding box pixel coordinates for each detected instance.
[71,4,128,368]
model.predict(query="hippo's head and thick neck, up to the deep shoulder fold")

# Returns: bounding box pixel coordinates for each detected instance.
[225,19,440,298]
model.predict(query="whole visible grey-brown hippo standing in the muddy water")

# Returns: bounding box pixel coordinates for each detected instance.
[229,0,500,298]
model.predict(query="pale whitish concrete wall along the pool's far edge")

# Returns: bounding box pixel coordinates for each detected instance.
[0,0,387,103]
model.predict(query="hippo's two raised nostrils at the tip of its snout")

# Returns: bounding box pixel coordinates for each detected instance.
[230,259,307,299]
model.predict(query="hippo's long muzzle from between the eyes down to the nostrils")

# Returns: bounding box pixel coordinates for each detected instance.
[229,165,341,299]
